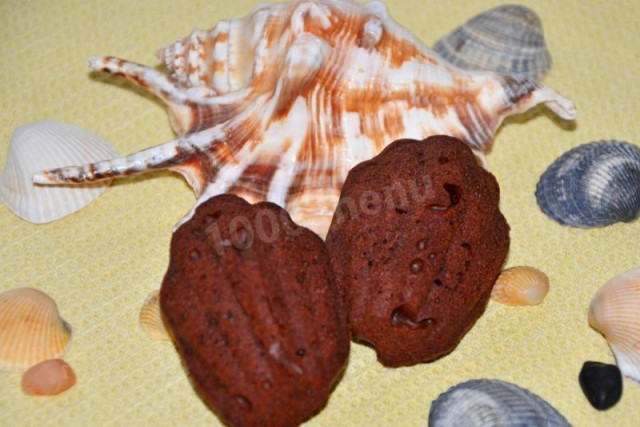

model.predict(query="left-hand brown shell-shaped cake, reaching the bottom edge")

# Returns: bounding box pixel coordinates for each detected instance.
[160,195,349,426]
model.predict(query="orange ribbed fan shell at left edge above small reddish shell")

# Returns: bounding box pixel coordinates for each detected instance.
[0,288,71,371]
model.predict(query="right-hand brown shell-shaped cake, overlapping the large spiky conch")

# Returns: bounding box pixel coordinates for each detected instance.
[327,136,509,366]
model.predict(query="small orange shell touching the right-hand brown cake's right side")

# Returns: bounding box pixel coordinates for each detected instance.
[491,266,549,305]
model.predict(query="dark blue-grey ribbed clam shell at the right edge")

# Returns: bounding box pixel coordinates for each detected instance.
[536,140,640,228]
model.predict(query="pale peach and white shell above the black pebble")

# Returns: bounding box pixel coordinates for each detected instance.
[589,268,640,382]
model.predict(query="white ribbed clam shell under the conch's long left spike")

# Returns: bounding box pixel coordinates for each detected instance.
[0,122,118,224]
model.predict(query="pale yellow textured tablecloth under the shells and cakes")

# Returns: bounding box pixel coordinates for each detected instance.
[0,0,640,426]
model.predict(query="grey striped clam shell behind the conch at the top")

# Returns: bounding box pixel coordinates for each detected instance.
[434,4,551,80]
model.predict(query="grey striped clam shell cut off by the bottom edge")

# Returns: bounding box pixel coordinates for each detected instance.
[429,379,570,427]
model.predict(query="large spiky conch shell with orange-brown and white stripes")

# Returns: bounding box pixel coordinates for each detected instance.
[34,0,575,236]
